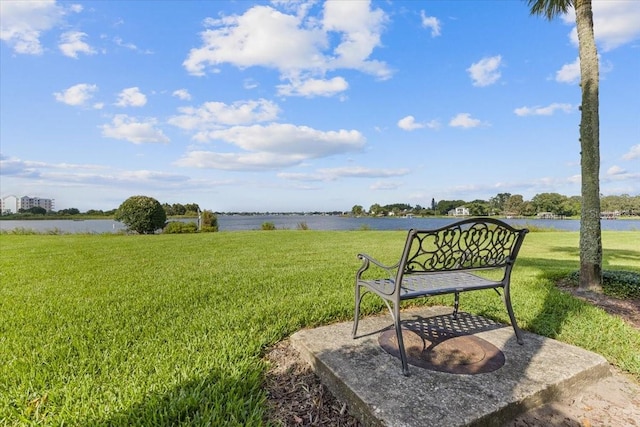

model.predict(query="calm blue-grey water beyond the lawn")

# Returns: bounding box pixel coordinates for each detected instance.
[0,215,640,233]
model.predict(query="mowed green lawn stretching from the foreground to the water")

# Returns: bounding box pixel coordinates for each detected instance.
[0,230,640,426]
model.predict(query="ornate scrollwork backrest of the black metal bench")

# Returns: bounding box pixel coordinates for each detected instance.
[398,218,529,275]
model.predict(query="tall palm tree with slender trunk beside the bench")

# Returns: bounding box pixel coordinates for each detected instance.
[526,0,602,290]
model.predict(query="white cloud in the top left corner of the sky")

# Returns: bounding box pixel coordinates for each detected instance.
[0,0,64,55]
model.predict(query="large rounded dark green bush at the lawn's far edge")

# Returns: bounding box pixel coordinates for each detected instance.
[114,196,167,234]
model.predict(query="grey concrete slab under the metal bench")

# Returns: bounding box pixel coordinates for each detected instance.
[291,307,610,427]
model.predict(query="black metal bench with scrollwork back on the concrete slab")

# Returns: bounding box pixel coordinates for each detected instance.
[353,218,529,375]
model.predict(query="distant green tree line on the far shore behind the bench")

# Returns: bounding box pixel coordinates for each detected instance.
[351,193,640,217]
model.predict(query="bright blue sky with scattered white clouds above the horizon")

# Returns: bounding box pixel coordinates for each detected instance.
[0,0,640,212]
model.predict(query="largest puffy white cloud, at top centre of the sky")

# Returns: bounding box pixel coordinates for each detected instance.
[183,1,391,96]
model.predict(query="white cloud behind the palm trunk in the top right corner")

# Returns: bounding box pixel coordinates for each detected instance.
[562,0,640,52]
